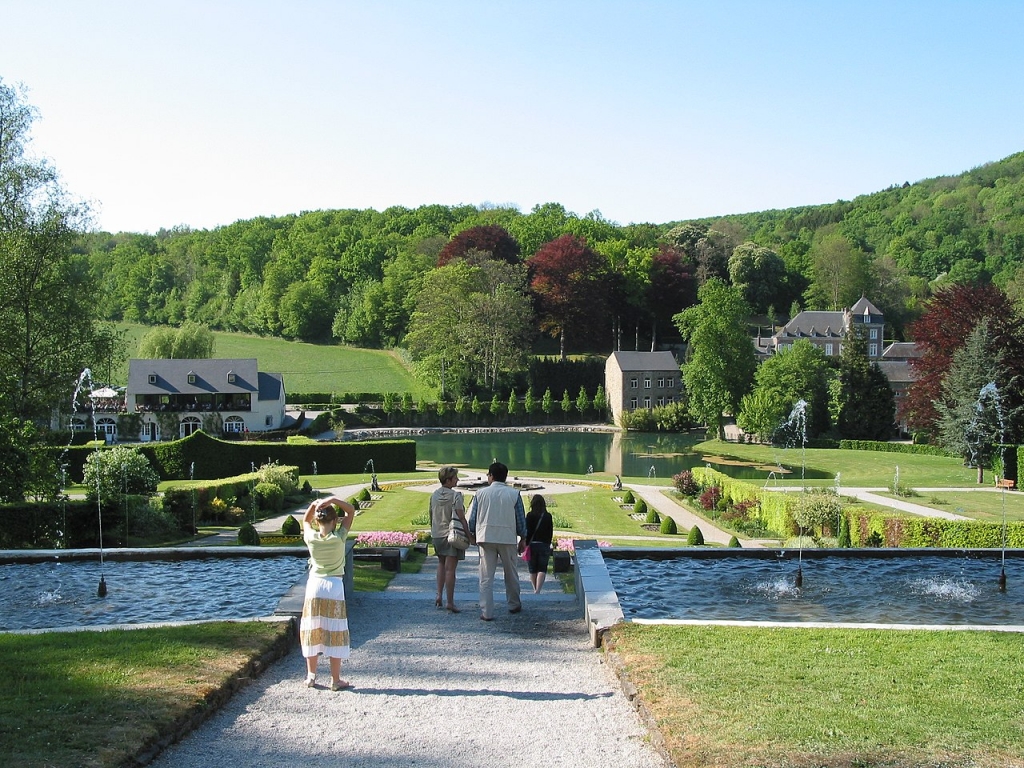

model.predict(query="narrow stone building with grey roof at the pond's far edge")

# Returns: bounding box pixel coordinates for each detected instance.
[604,352,683,424]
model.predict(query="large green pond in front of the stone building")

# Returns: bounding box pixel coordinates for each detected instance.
[403,431,829,482]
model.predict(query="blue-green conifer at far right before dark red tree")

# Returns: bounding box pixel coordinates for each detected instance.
[935,318,1008,483]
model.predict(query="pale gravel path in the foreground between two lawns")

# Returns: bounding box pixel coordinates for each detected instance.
[153,550,665,768]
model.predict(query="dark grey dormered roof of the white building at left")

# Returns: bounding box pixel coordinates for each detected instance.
[128,357,262,399]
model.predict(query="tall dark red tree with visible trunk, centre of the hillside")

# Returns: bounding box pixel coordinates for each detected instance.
[528,234,608,360]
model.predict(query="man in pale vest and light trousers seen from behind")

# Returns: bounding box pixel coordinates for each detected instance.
[469,462,526,622]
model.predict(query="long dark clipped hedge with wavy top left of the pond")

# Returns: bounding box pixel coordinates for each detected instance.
[48,431,416,482]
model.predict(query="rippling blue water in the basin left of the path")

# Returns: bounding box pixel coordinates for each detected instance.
[0,556,307,630]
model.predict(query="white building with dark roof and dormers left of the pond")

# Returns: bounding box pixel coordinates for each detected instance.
[123,357,285,441]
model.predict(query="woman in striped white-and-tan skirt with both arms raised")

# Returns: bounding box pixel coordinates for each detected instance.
[299,496,355,690]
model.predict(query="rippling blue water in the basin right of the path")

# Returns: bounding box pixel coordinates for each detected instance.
[604,553,1024,625]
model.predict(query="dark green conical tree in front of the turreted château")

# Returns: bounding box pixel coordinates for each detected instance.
[829,334,896,440]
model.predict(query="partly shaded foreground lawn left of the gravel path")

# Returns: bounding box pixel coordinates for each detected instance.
[0,622,292,768]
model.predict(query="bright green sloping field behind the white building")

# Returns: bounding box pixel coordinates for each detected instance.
[112,323,434,399]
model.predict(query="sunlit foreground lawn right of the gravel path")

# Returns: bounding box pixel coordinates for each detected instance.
[606,624,1024,768]
